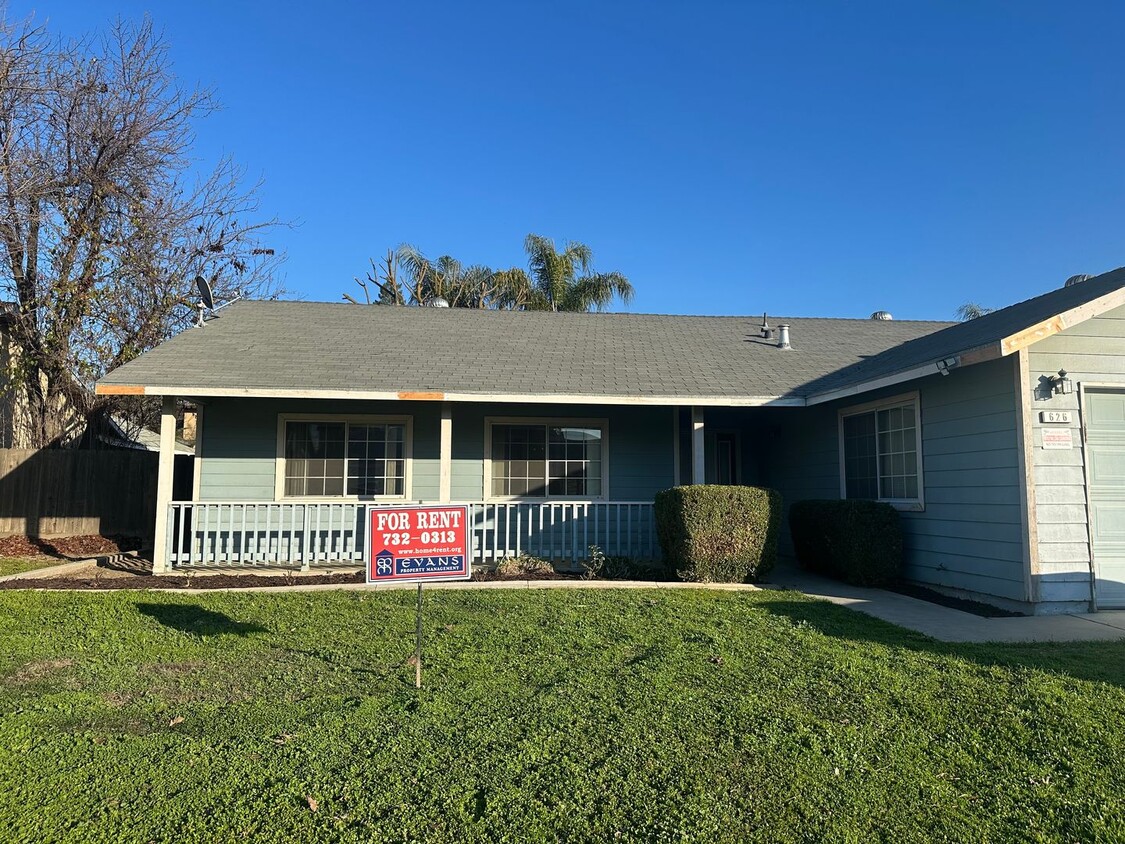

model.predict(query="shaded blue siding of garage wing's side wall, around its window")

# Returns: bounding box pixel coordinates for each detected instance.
[761,359,1027,601]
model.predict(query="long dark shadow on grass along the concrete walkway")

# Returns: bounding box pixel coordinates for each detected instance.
[759,596,1125,688]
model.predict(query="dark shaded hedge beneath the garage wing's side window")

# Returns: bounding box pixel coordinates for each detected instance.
[789,500,902,586]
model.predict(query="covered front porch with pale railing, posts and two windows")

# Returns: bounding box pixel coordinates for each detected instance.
[153,397,783,573]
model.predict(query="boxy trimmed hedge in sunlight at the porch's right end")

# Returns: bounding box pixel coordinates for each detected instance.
[655,484,781,583]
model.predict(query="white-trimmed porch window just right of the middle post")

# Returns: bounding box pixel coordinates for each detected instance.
[488,420,605,499]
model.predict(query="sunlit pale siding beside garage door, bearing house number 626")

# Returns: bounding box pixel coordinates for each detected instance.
[1024,307,1125,602]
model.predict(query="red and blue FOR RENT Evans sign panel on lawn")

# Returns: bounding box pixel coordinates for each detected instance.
[367,505,471,583]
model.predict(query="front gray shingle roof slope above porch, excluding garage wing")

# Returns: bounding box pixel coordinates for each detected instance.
[102,302,947,407]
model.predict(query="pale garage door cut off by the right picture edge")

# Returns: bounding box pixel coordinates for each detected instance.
[1083,389,1125,609]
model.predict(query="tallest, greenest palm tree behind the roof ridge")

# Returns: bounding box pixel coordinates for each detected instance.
[515,234,633,312]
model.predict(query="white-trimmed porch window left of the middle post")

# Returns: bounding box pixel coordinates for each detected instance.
[282,419,407,499]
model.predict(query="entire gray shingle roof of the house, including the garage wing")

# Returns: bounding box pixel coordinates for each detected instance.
[98,270,1125,405]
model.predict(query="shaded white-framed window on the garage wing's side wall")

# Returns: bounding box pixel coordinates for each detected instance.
[839,394,923,510]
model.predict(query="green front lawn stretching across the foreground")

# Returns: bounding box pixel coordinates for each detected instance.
[0,590,1125,843]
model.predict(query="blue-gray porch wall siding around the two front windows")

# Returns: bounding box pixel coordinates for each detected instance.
[199,398,673,501]
